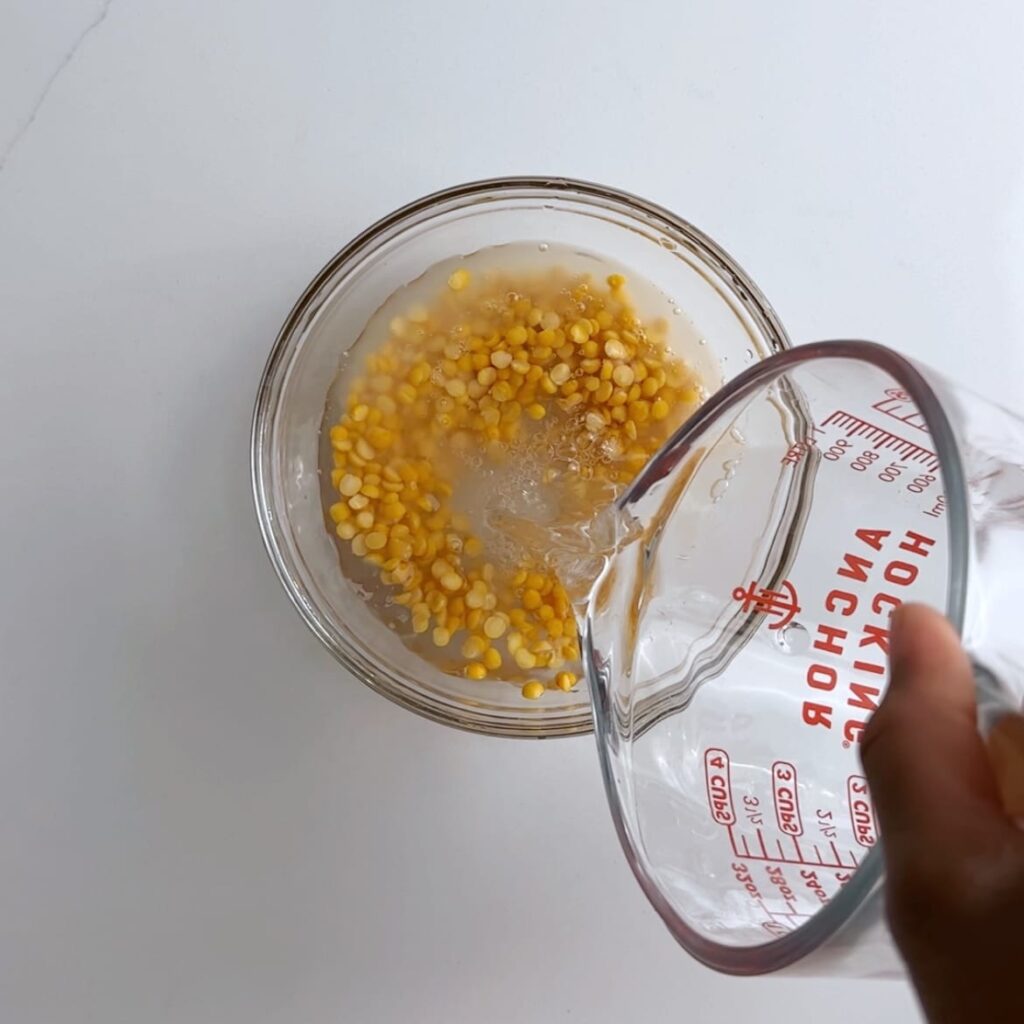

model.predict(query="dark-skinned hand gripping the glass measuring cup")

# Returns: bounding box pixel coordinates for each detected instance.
[861,605,1024,1024]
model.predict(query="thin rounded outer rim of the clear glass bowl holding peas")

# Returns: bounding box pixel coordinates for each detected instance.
[250,175,792,739]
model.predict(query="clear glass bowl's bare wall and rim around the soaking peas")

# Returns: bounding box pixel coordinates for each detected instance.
[252,177,790,737]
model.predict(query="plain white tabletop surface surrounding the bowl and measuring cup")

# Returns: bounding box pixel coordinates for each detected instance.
[0,0,1024,1024]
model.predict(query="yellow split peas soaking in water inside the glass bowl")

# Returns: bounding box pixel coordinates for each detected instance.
[329,260,699,699]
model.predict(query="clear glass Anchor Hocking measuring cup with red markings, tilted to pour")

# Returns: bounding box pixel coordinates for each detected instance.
[584,341,1024,974]
